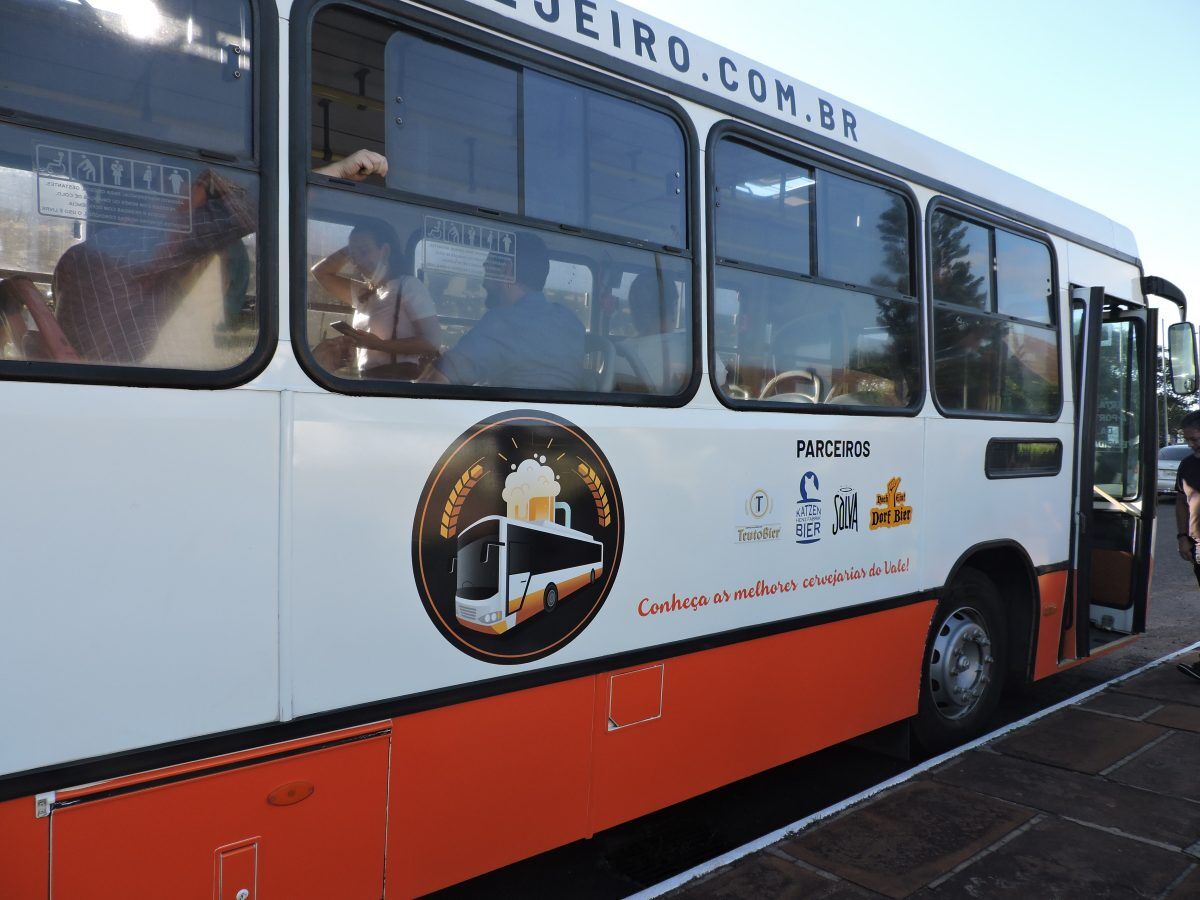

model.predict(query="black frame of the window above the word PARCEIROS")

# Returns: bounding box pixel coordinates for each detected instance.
[704,119,929,419]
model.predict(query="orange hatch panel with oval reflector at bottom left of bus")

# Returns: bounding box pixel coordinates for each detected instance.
[50,734,389,900]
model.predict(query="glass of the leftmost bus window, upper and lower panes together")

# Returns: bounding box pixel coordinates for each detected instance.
[0,0,262,380]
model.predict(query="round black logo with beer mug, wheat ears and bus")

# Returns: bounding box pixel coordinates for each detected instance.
[413,410,624,664]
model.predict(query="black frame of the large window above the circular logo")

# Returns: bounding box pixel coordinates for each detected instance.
[289,0,702,408]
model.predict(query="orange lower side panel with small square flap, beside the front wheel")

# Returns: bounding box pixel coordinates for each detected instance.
[589,600,936,832]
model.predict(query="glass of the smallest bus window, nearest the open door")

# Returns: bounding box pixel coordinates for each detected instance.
[930,209,1061,418]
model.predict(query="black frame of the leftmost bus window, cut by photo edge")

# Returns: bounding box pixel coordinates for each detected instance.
[0,0,280,390]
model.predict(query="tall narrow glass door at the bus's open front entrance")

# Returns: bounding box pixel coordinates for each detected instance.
[1078,299,1156,655]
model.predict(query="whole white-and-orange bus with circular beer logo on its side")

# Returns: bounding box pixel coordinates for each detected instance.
[0,0,1195,900]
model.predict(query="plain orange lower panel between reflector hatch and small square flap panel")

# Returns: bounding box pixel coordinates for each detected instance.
[388,678,596,896]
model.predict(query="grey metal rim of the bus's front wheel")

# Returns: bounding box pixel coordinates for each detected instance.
[929,606,996,719]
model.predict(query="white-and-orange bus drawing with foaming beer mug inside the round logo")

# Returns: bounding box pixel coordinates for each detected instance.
[452,456,604,635]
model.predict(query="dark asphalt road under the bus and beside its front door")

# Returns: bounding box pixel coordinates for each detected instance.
[436,498,1200,900]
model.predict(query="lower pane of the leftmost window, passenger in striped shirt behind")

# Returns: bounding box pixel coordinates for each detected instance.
[0,131,258,371]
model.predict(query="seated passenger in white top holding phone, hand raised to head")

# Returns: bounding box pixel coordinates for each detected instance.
[312,218,442,378]
